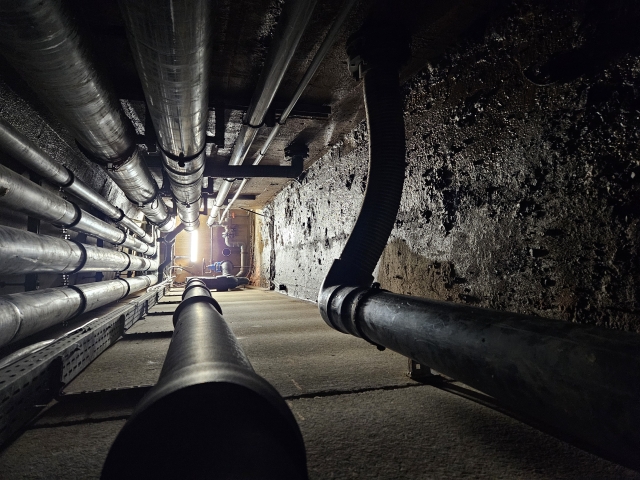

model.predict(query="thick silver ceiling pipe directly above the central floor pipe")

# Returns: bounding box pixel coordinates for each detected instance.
[119,0,211,231]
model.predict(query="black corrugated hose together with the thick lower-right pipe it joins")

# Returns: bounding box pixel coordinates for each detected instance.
[318,21,640,468]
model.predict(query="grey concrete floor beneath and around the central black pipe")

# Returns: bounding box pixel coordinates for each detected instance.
[0,289,640,479]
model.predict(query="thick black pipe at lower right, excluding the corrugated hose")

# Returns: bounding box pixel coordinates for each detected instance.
[323,287,640,468]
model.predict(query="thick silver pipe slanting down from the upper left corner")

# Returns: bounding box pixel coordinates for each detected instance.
[0,0,173,231]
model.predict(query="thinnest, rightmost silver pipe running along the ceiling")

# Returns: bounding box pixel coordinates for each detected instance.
[220,0,357,223]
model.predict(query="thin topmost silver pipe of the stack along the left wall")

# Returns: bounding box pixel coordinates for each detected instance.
[0,117,154,244]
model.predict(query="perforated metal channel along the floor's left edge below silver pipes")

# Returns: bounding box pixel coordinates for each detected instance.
[0,289,164,446]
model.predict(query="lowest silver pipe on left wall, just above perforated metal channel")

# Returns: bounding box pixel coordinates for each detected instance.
[0,275,158,347]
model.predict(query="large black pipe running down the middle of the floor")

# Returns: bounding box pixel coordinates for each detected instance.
[102,279,308,480]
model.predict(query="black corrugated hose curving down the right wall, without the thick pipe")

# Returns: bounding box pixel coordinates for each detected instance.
[323,22,410,288]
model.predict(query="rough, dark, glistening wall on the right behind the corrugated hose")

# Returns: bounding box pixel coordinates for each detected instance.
[260,1,640,331]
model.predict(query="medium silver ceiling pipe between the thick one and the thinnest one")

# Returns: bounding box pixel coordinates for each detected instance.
[207,0,317,226]
